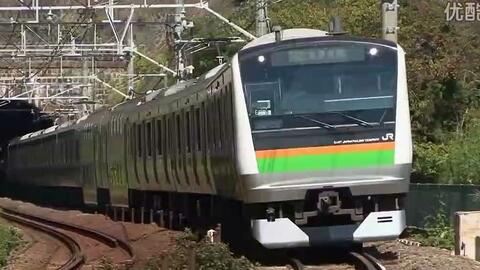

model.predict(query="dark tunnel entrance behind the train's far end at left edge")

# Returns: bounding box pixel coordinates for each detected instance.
[0,100,53,184]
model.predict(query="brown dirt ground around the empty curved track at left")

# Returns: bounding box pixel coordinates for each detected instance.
[0,198,178,270]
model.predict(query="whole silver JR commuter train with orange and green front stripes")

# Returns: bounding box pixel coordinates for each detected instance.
[7,29,412,249]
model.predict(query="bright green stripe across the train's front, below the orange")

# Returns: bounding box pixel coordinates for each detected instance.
[257,150,395,173]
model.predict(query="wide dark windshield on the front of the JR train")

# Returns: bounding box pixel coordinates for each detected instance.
[240,41,397,129]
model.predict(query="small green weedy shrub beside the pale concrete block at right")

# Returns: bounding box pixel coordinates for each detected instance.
[412,202,455,250]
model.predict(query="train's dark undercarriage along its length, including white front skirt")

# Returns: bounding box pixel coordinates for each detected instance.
[2,177,405,249]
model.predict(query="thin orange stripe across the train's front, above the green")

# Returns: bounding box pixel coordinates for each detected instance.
[255,142,395,158]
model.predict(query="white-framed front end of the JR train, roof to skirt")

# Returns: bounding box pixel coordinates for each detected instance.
[232,29,412,248]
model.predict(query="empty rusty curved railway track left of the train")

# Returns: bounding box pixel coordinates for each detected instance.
[0,208,135,270]
